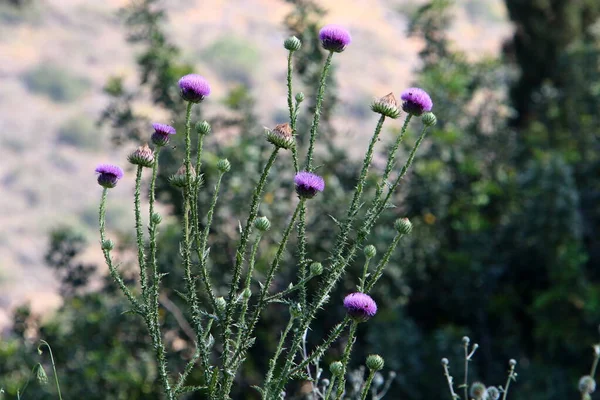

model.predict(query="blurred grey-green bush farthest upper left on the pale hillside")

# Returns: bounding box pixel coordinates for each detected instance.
[22,63,90,103]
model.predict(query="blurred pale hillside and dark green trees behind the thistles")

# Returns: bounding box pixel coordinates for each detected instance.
[0,0,600,400]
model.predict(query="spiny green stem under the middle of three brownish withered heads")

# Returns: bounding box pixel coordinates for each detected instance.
[223,147,279,365]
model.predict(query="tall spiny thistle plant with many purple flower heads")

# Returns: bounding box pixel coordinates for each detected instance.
[96,25,436,400]
